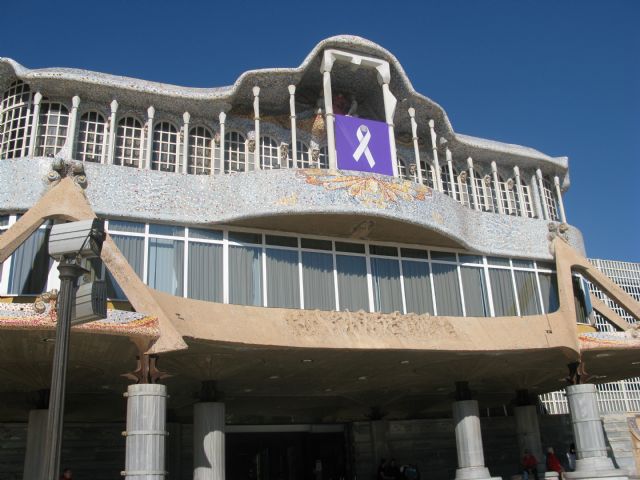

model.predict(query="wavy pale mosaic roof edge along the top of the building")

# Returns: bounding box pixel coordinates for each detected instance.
[0,35,568,175]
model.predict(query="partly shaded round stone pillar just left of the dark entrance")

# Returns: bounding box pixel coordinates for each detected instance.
[193,402,225,480]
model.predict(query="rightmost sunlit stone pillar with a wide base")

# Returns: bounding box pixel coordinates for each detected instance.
[565,383,628,480]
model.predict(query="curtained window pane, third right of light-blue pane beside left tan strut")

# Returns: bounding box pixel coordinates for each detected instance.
[266,248,300,308]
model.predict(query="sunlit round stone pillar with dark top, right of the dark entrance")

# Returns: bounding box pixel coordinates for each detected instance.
[453,400,499,480]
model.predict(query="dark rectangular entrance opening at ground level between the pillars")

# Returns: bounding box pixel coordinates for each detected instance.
[225,432,347,480]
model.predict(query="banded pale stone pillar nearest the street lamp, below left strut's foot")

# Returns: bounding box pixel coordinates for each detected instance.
[122,383,167,480]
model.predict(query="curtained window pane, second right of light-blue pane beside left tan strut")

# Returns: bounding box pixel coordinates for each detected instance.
[229,245,262,306]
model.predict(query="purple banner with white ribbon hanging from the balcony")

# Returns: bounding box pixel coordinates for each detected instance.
[335,115,393,175]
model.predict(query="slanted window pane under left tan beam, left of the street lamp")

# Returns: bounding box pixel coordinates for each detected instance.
[8,228,53,295]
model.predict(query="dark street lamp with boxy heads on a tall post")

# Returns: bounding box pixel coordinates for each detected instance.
[43,219,107,480]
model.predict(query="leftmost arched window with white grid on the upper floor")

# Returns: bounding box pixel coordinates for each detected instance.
[0,80,31,158]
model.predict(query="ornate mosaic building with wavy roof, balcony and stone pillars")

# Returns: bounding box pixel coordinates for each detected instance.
[0,36,640,480]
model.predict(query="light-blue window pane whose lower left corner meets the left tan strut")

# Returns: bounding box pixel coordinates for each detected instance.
[147,238,184,296]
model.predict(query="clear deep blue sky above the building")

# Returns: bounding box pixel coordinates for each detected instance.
[0,0,640,262]
